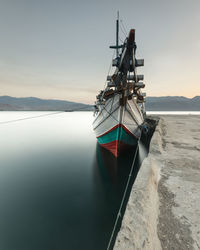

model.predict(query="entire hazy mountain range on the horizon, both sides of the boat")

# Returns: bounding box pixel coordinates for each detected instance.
[0,96,200,111]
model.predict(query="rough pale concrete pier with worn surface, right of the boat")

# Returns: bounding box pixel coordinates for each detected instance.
[114,115,200,250]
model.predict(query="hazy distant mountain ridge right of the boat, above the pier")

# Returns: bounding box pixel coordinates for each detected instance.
[146,96,200,111]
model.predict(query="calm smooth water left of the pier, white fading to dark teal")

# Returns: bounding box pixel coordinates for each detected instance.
[0,112,145,250]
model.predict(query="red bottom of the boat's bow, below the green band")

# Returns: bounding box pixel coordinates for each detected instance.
[99,140,130,157]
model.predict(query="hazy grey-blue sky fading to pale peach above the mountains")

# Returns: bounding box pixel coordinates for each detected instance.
[0,0,200,103]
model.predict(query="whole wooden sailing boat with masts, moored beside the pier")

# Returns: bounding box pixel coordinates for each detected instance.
[93,15,145,157]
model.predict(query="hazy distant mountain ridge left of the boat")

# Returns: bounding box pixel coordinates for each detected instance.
[0,96,92,111]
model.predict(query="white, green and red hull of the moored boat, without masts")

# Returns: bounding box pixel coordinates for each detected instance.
[93,94,143,157]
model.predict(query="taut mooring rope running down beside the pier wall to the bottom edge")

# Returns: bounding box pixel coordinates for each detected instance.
[107,136,141,250]
